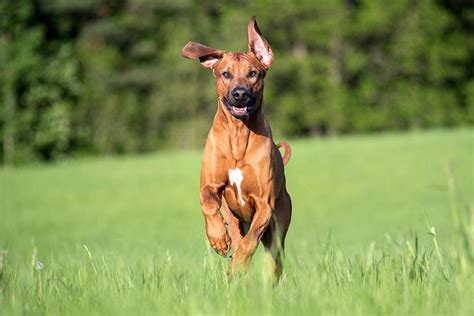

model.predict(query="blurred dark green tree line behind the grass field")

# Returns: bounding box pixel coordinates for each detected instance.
[0,0,474,163]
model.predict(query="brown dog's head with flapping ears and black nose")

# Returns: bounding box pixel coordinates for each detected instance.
[181,17,273,119]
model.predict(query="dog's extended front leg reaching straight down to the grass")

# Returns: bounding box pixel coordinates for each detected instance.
[229,200,272,272]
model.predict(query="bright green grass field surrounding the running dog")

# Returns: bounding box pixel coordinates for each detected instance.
[0,129,474,315]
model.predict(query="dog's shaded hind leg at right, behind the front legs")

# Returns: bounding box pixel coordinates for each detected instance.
[262,190,291,281]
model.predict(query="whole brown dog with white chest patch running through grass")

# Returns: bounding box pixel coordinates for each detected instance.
[181,17,291,277]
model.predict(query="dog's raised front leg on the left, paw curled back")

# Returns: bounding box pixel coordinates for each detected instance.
[201,185,231,257]
